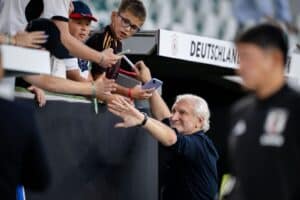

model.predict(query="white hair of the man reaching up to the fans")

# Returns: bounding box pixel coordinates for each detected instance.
[175,94,210,132]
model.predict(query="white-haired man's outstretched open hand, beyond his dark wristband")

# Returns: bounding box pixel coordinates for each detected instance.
[108,95,144,128]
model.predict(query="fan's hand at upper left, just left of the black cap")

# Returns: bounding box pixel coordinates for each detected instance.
[12,31,48,48]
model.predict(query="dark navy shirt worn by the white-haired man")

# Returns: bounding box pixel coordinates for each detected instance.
[160,119,219,200]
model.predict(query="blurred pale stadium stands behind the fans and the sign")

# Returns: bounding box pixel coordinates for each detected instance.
[87,0,300,43]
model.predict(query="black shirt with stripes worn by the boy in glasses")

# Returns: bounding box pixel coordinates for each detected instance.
[86,26,122,79]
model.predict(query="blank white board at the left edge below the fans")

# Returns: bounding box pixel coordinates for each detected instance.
[0,45,50,74]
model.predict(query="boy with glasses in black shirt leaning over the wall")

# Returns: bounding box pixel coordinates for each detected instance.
[86,0,153,101]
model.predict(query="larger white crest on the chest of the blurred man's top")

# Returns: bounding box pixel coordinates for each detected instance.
[259,108,288,147]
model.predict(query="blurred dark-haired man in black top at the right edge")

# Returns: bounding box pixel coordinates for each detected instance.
[229,24,300,200]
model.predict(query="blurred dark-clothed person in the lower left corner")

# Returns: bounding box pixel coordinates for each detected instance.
[0,53,50,200]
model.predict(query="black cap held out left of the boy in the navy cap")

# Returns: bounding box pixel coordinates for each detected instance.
[26,18,72,59]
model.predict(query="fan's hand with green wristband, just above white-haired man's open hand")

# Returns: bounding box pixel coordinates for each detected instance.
[94,73,116,99]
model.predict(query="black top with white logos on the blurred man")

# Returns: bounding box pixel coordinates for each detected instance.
[229,85,300,200]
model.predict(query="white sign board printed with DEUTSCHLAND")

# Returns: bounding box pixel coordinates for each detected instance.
[158,29,239,69]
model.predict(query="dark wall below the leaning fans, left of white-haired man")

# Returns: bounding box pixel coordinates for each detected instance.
[18,99,158,200]
